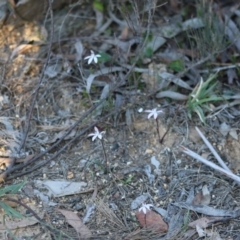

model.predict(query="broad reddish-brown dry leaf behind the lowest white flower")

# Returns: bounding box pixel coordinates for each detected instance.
[136,211,168,233]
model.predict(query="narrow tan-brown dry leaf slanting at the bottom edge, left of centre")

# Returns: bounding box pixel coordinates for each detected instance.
[58,209,92,238]
